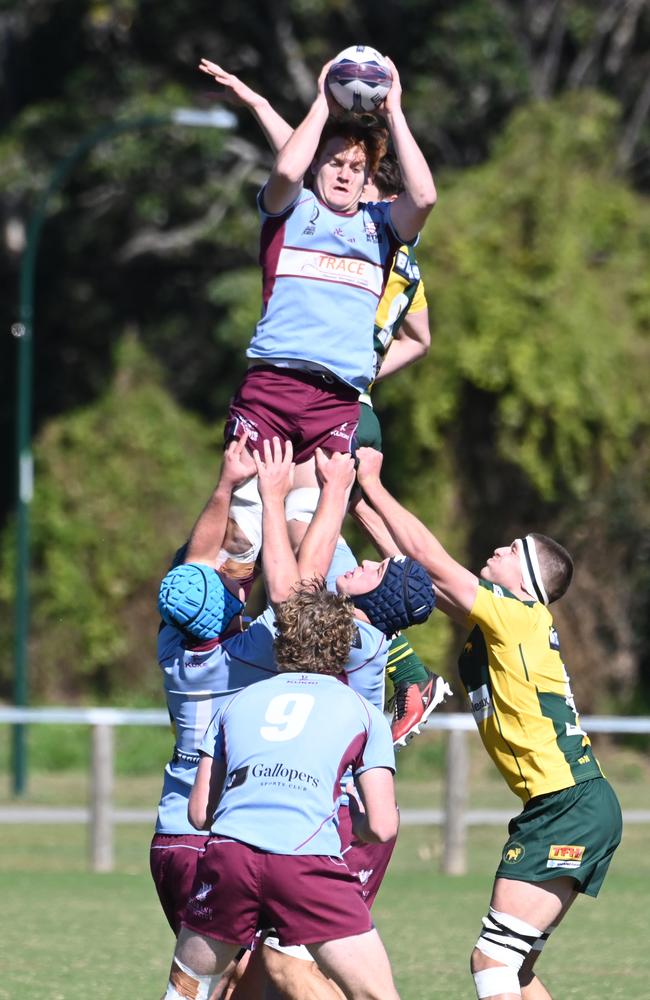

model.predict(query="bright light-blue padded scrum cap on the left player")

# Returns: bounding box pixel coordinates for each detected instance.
[158,563,244,641]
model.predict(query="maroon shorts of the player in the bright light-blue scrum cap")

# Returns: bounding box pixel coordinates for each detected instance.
[149,833,207,936]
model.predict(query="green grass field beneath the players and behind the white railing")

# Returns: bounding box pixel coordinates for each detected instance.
[0,738,650,1000]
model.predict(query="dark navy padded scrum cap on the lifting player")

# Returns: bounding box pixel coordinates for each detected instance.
[352,556,436,635]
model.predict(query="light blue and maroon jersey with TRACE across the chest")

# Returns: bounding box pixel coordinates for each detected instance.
[246,188,403,392]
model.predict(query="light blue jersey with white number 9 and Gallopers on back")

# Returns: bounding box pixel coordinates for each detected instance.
[201,673,395,857]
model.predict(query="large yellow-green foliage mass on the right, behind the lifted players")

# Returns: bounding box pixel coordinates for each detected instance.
[381,93,650,499]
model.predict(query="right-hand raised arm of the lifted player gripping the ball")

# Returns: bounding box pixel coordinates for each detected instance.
[379,59,438,243]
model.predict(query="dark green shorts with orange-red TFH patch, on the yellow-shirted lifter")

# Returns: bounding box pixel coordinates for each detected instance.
[496,778,623,896]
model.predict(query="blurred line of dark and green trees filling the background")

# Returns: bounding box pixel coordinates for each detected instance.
[0,0,650,708]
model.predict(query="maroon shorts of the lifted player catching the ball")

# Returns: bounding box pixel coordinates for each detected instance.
[224,365,359,462]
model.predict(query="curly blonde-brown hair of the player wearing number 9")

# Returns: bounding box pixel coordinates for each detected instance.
[273,578,356,674]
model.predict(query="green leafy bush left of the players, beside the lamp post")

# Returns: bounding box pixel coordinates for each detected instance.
[0,335,218,699]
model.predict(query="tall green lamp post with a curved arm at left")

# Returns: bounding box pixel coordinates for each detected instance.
[12,108,236,795]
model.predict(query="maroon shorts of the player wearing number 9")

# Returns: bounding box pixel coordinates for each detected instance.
[183,837,373,946]
